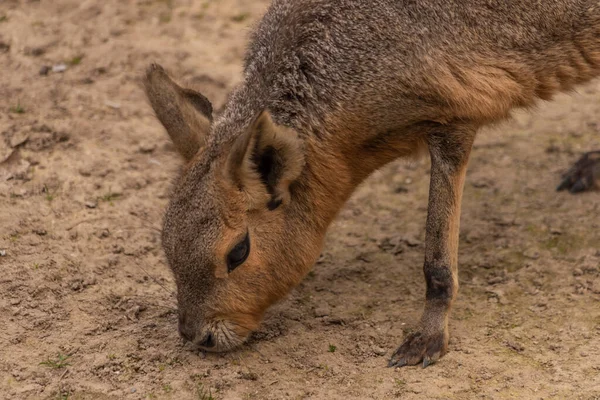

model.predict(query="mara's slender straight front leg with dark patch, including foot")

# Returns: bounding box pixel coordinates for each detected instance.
[389,127,475,367]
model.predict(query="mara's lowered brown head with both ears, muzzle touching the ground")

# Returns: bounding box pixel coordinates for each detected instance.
[145,65,324,351]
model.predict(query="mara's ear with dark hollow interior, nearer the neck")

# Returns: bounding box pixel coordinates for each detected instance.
[226,110,304,210]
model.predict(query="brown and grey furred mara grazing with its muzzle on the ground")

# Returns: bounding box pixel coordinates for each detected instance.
[146,0,600,366]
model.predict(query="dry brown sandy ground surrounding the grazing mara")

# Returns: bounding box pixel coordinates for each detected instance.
[0,0,600,400]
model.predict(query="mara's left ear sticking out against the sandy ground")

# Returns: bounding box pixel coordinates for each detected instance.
[144,64,212,161]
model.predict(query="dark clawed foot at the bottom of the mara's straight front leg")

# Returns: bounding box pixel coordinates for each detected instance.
[388,332,448,368]
